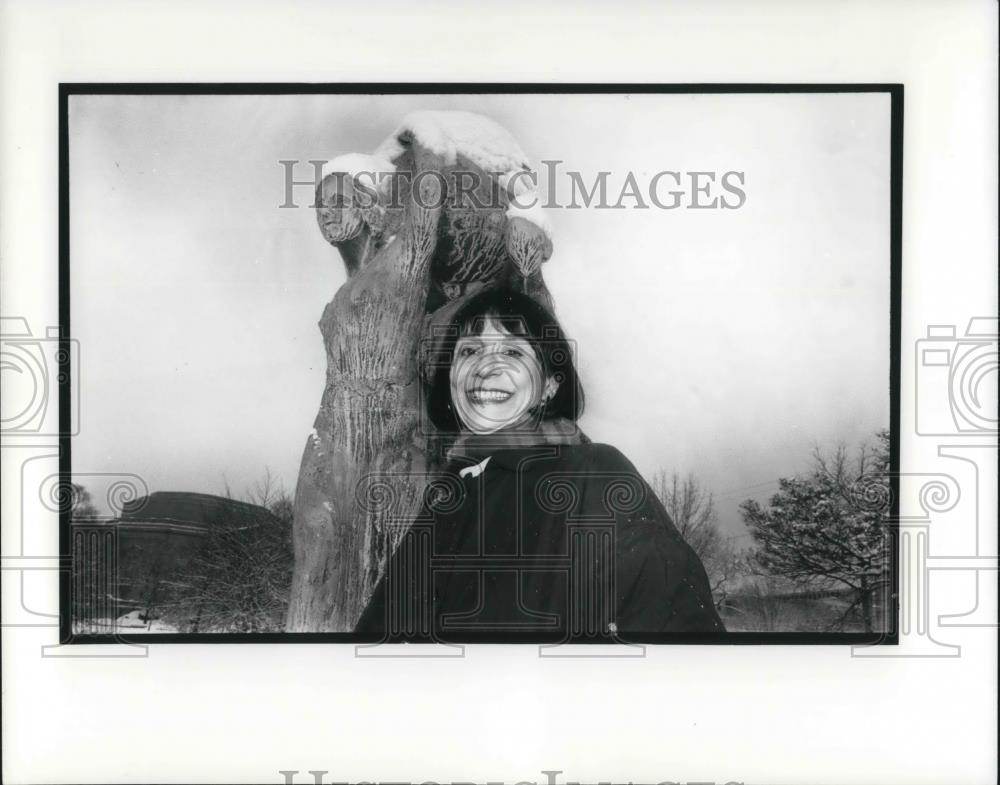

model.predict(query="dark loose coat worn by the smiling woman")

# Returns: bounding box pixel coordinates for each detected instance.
[355,443,725,642]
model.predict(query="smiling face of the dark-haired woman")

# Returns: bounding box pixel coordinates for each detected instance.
[450,318,558,433]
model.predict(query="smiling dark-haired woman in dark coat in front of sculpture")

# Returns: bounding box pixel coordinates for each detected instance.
[355,289,725,642]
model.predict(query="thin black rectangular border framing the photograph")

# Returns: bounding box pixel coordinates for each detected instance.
[58,82,903,646]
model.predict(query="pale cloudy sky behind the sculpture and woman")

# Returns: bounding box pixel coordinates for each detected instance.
[70,94,889,536]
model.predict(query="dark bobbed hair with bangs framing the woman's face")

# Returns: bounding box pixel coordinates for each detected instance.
[426,288,583,433]
